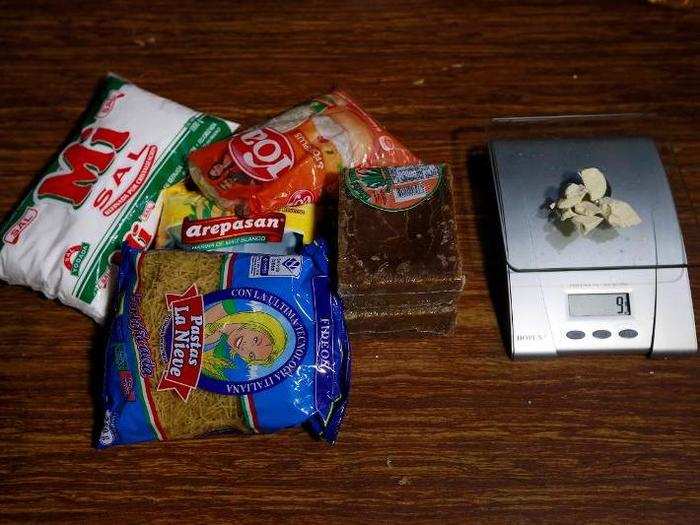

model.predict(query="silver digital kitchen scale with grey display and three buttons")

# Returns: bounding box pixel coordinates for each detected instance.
[489,138,697,359]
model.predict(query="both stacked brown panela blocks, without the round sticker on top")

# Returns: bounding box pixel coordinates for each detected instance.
[338,166,464,335]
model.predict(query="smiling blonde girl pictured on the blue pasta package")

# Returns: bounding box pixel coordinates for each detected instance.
[202,303,287,381]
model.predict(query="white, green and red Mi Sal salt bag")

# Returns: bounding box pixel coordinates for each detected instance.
[0,75,237,322]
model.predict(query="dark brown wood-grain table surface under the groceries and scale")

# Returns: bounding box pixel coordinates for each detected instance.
[0,0,700,523]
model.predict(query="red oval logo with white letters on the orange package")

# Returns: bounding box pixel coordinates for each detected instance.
[228,128,294,182]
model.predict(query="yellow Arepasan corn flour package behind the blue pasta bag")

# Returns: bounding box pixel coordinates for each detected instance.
[156,181,314,255]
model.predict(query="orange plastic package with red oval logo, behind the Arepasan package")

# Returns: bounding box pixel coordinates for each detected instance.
[189,91,420,216]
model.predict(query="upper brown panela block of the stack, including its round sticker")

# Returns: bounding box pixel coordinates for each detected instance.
[338,165,464,310]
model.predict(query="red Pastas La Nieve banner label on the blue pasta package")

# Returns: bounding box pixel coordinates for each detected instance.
[158,284,204,401]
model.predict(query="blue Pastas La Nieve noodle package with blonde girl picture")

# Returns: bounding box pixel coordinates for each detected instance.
[97,241,350,448]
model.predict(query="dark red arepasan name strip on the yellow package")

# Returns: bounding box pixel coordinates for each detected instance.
[181,213,285,245]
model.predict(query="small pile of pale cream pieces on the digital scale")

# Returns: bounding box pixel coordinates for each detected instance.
[549,168,642,235]
